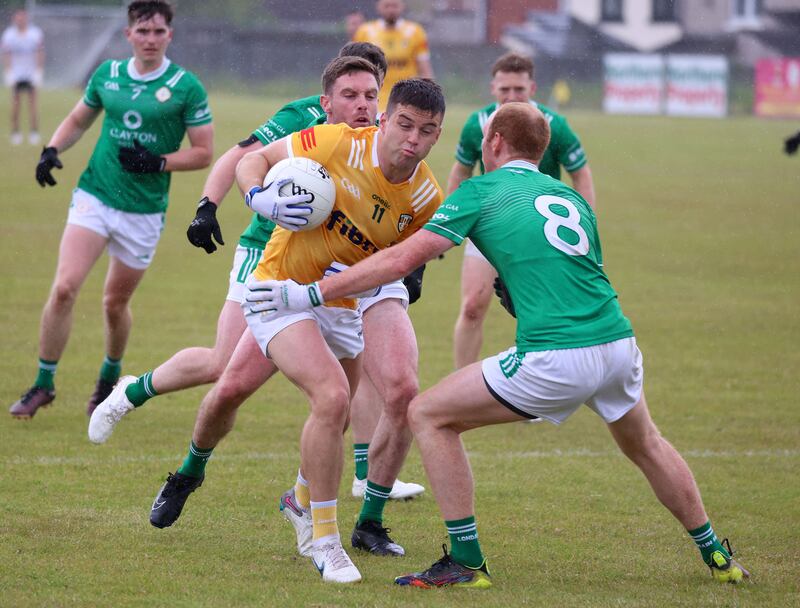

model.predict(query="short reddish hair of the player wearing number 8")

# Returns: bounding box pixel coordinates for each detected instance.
[486,101,550,163]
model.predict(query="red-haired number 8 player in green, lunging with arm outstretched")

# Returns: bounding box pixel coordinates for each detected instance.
[255,102,749,588]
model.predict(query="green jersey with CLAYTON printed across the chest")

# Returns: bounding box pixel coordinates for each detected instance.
[78,58,211,213]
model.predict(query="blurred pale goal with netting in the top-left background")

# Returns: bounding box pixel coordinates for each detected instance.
[25,0,130,88]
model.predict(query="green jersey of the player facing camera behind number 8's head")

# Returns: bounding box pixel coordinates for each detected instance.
[456,101,586,179]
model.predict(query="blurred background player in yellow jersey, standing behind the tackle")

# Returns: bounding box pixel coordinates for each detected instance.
[353,0,433,112]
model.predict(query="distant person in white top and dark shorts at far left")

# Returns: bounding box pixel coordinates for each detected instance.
[0,9,44,146]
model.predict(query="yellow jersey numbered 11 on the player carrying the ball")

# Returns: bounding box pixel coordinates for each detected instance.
[254,124,444,308]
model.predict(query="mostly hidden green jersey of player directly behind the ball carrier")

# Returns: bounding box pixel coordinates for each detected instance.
[239,95,325,249]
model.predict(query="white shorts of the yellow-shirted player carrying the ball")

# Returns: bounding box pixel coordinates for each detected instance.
[242,303,364,359]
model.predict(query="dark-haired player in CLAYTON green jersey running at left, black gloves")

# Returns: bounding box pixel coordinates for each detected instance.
[11,0,213,418]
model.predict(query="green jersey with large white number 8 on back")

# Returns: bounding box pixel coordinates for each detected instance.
[425,161,633,353]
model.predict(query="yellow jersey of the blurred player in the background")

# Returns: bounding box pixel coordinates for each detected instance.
[353,19,430,112]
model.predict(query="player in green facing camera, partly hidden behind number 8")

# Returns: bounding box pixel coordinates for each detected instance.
[454,53,594,369]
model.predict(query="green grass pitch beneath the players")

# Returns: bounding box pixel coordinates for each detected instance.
[0,91,800,607]
